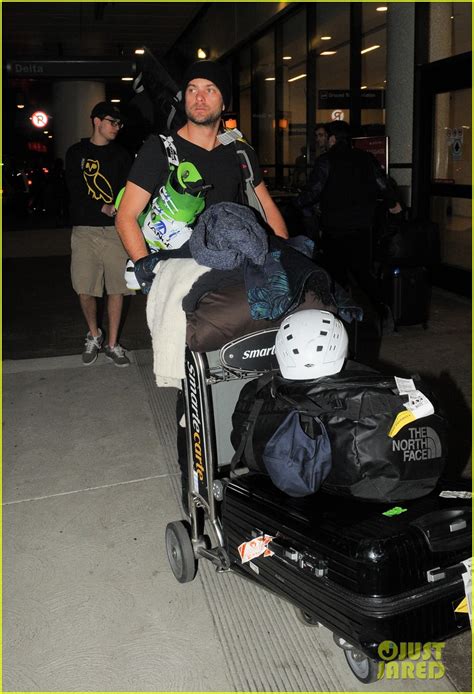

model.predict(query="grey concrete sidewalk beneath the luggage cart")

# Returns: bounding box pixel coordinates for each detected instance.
[3,334,471,692]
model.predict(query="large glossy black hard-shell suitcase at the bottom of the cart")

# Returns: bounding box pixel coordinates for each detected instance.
[222,474,471,661]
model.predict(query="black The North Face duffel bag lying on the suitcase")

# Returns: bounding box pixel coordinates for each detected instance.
[231,362,447,502]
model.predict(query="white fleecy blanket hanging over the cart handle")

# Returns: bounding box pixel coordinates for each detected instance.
[146,258,210,388]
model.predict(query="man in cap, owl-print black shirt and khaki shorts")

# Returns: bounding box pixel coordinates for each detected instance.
[65,101,134,367]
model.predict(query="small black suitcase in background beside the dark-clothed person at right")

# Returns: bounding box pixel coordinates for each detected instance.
[380,265,431,328]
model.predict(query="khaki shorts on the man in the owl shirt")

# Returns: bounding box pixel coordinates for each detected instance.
[71,226,135,297]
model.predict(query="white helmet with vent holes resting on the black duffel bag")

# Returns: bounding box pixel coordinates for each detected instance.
[275,309,349,381]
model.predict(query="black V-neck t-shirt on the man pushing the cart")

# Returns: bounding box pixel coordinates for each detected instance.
[128,132,262,208]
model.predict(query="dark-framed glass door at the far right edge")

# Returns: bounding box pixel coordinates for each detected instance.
[413,53,472,296]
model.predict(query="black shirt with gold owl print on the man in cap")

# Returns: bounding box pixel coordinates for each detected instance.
[66,138,132,226]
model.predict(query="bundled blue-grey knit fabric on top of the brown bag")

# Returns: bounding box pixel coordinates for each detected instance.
[189,202,268,270]
